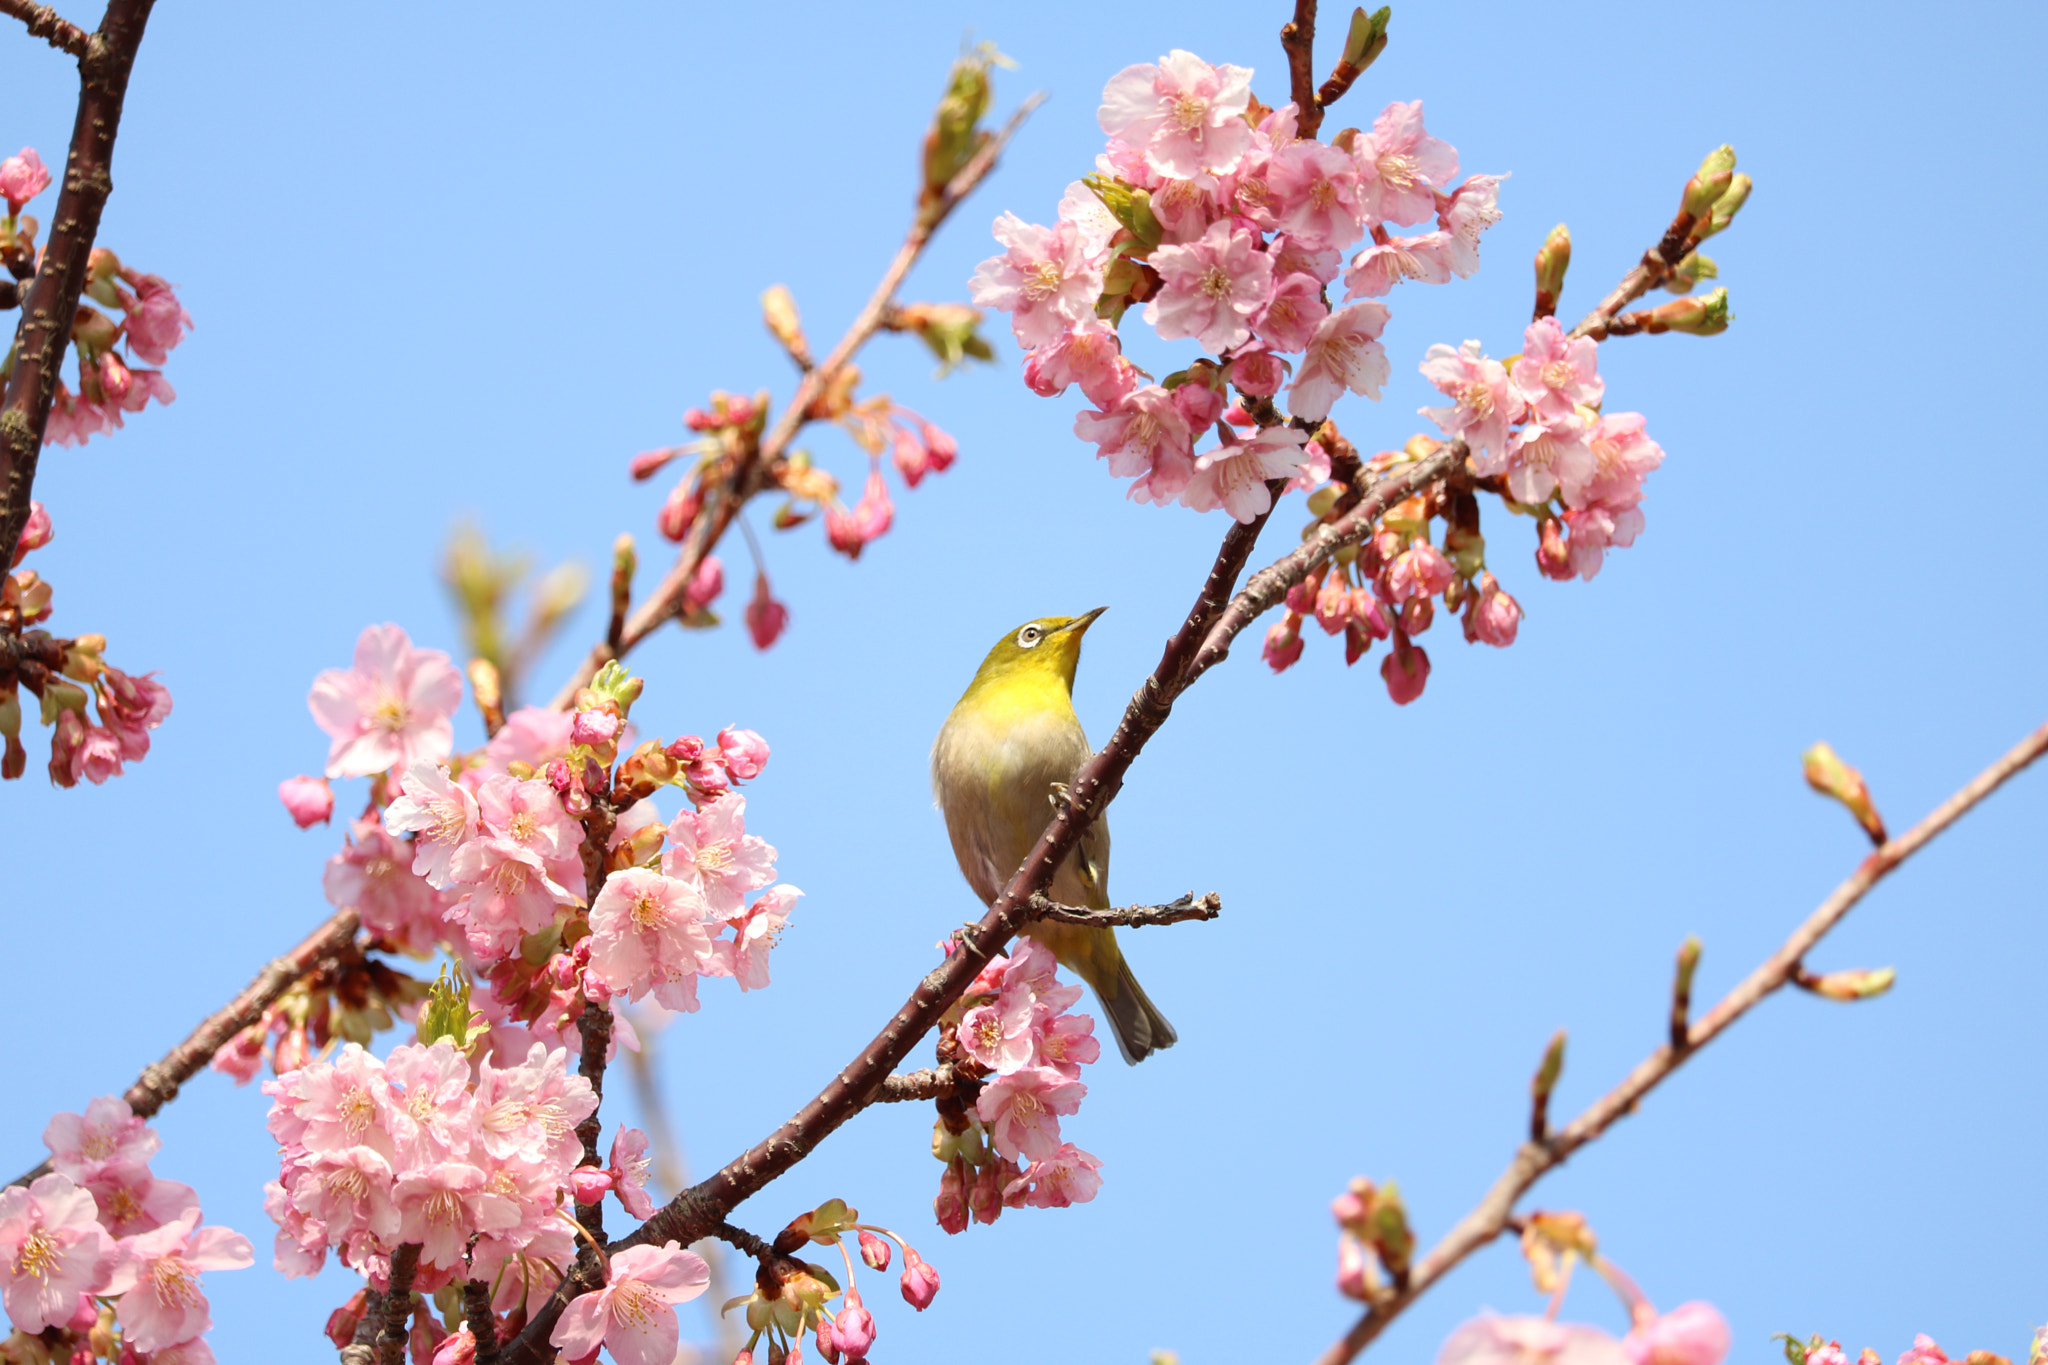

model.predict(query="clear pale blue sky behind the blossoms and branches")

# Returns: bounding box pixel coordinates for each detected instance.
[0,0,2048,1365]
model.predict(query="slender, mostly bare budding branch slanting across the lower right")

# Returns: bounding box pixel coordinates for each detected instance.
[1317,724,2048,1365]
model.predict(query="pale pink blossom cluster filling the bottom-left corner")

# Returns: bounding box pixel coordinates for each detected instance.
[0,1095,256,1365]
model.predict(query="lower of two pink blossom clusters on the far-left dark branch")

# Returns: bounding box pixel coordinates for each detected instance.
[0,501,170,786]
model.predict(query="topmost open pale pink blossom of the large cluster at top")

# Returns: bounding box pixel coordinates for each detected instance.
[1096,47,1251,180]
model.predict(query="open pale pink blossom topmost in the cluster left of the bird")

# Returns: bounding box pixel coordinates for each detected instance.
[307,626,463,778]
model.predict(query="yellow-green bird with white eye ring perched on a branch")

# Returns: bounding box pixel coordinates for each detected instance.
[932,606,1176,1064]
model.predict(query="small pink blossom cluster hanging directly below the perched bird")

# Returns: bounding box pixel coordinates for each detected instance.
[932,937,1102,1232]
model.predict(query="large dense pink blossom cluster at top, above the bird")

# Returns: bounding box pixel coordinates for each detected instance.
[973,51,1499,522]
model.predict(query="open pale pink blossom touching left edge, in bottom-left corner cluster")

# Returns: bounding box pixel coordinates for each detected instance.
[0,1173,121,1332]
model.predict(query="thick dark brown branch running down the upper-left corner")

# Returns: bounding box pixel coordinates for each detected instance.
[0,0,156,548]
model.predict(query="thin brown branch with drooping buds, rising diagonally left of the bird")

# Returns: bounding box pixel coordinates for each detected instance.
[555,94,1044,710]
